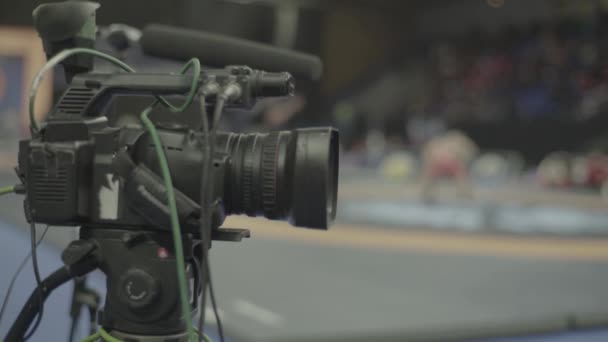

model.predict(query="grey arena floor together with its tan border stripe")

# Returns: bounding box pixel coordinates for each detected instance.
[0,174,608,342]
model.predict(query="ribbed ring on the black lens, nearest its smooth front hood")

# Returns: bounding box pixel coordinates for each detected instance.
[262,132,279,219]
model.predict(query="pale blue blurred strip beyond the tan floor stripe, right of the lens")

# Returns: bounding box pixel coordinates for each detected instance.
[338,199,608,236]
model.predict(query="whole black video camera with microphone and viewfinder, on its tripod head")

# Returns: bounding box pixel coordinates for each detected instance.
[5,2,338,342]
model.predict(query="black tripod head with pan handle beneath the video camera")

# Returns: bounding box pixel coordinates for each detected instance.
[5,227,201,342]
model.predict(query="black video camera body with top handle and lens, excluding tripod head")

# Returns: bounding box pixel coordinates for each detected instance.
[18,66,338,235]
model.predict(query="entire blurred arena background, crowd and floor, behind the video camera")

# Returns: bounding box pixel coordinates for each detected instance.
[0,0,608,342]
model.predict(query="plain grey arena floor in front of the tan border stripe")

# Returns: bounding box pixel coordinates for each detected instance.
[0,174,608,341]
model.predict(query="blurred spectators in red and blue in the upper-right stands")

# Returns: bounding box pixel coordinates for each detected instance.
[407,12,608,122]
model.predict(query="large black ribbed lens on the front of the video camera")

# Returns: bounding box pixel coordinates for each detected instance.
[221,128,339,229]
